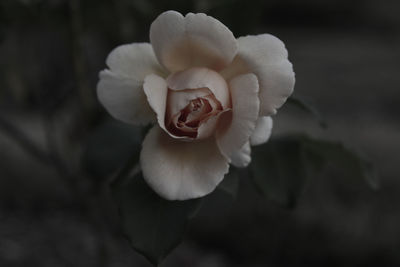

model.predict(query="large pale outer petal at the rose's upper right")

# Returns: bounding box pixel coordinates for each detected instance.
[222,34,295,116]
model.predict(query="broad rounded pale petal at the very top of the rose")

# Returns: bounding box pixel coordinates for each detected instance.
[150,11,237,72]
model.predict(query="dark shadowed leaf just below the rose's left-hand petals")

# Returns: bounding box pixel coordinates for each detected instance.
[82,120,143,178]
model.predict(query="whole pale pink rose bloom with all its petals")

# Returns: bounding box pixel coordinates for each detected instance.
[97,11,295,200]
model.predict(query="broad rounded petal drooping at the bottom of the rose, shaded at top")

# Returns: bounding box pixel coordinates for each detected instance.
[140,126,229,200]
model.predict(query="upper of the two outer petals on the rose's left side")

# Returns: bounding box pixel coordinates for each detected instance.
[106,43,166,82]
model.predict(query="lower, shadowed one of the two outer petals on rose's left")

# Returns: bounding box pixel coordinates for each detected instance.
[97,70,155,124]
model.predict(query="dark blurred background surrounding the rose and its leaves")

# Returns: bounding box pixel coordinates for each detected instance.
[0,0,400,267]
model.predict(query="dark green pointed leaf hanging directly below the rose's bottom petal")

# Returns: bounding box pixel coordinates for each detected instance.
[112,173,201,265]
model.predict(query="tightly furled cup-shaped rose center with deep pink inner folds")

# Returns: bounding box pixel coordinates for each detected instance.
[165,68,230,140]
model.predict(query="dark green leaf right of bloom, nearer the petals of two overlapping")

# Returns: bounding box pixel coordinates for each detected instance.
[251,138,307,207]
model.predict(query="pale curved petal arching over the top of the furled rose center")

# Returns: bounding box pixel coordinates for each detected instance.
[167,68,230,109]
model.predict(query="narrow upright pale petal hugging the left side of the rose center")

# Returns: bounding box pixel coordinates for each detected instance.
[143,74,168,131]
